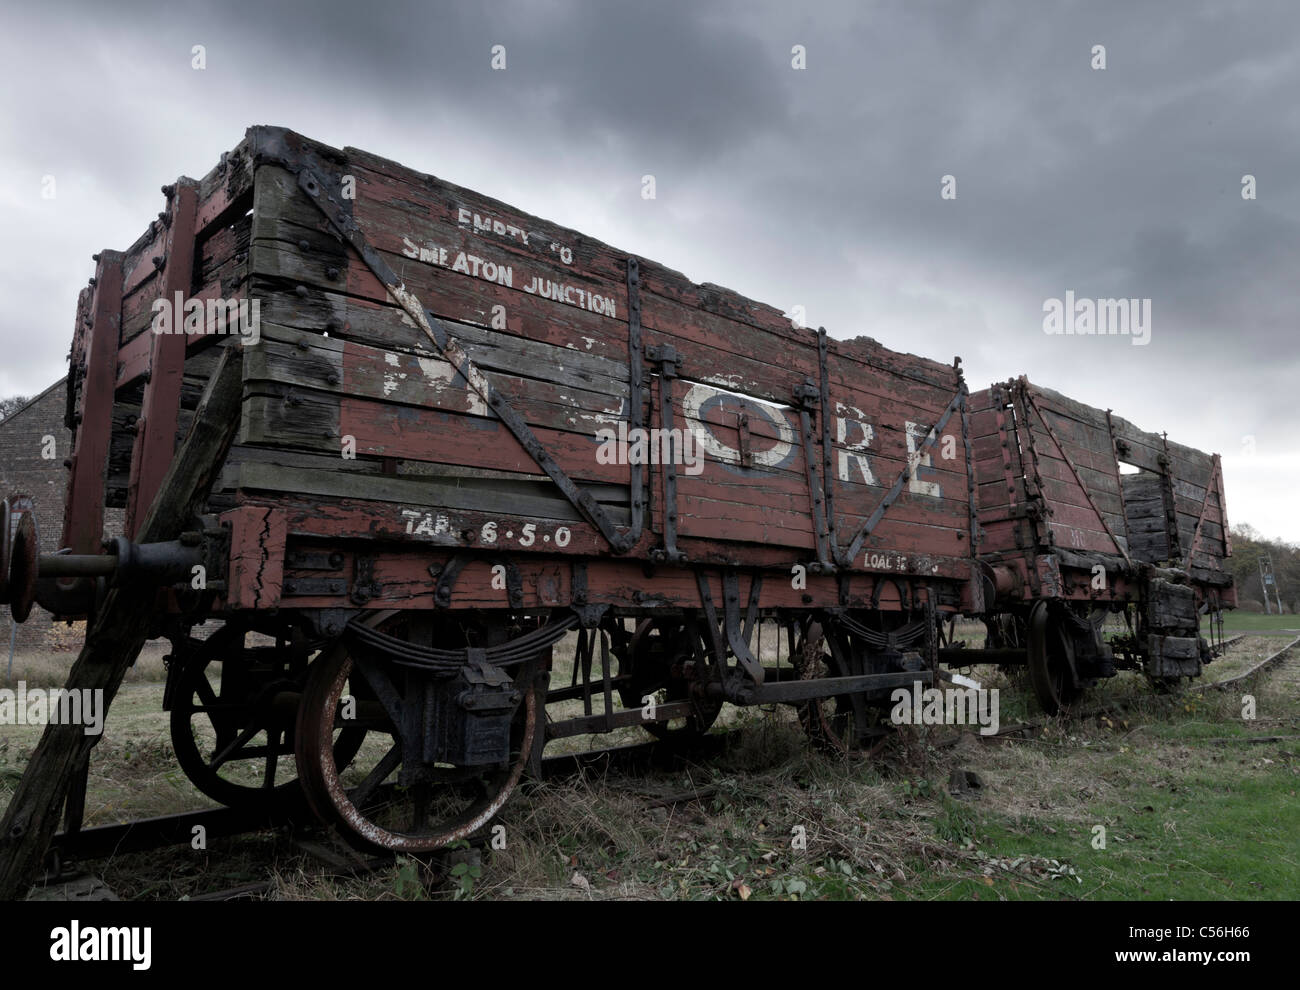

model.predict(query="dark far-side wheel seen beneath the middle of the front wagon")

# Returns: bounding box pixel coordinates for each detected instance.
[619,618,723,742]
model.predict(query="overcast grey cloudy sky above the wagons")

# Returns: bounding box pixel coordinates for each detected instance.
[0,0,1300,542]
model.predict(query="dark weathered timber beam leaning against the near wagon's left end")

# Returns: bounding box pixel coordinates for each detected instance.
[0,343,243,900]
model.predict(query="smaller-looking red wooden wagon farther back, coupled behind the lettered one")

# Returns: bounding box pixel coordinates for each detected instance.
[961,378,1236,712]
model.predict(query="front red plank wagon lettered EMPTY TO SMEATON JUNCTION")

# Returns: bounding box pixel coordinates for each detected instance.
[5,127,984,850]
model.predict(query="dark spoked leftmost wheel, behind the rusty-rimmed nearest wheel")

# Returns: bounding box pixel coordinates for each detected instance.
[170,633,365,808]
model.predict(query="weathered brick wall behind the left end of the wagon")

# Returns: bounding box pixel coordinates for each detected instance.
[0,379,122,654]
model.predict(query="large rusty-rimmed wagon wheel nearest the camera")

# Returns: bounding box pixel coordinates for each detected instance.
[295,615,538,852]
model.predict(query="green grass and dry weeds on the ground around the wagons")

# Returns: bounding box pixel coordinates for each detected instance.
[0,631,1300,900]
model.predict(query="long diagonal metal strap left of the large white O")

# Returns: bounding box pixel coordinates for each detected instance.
[281,160,634,553]
